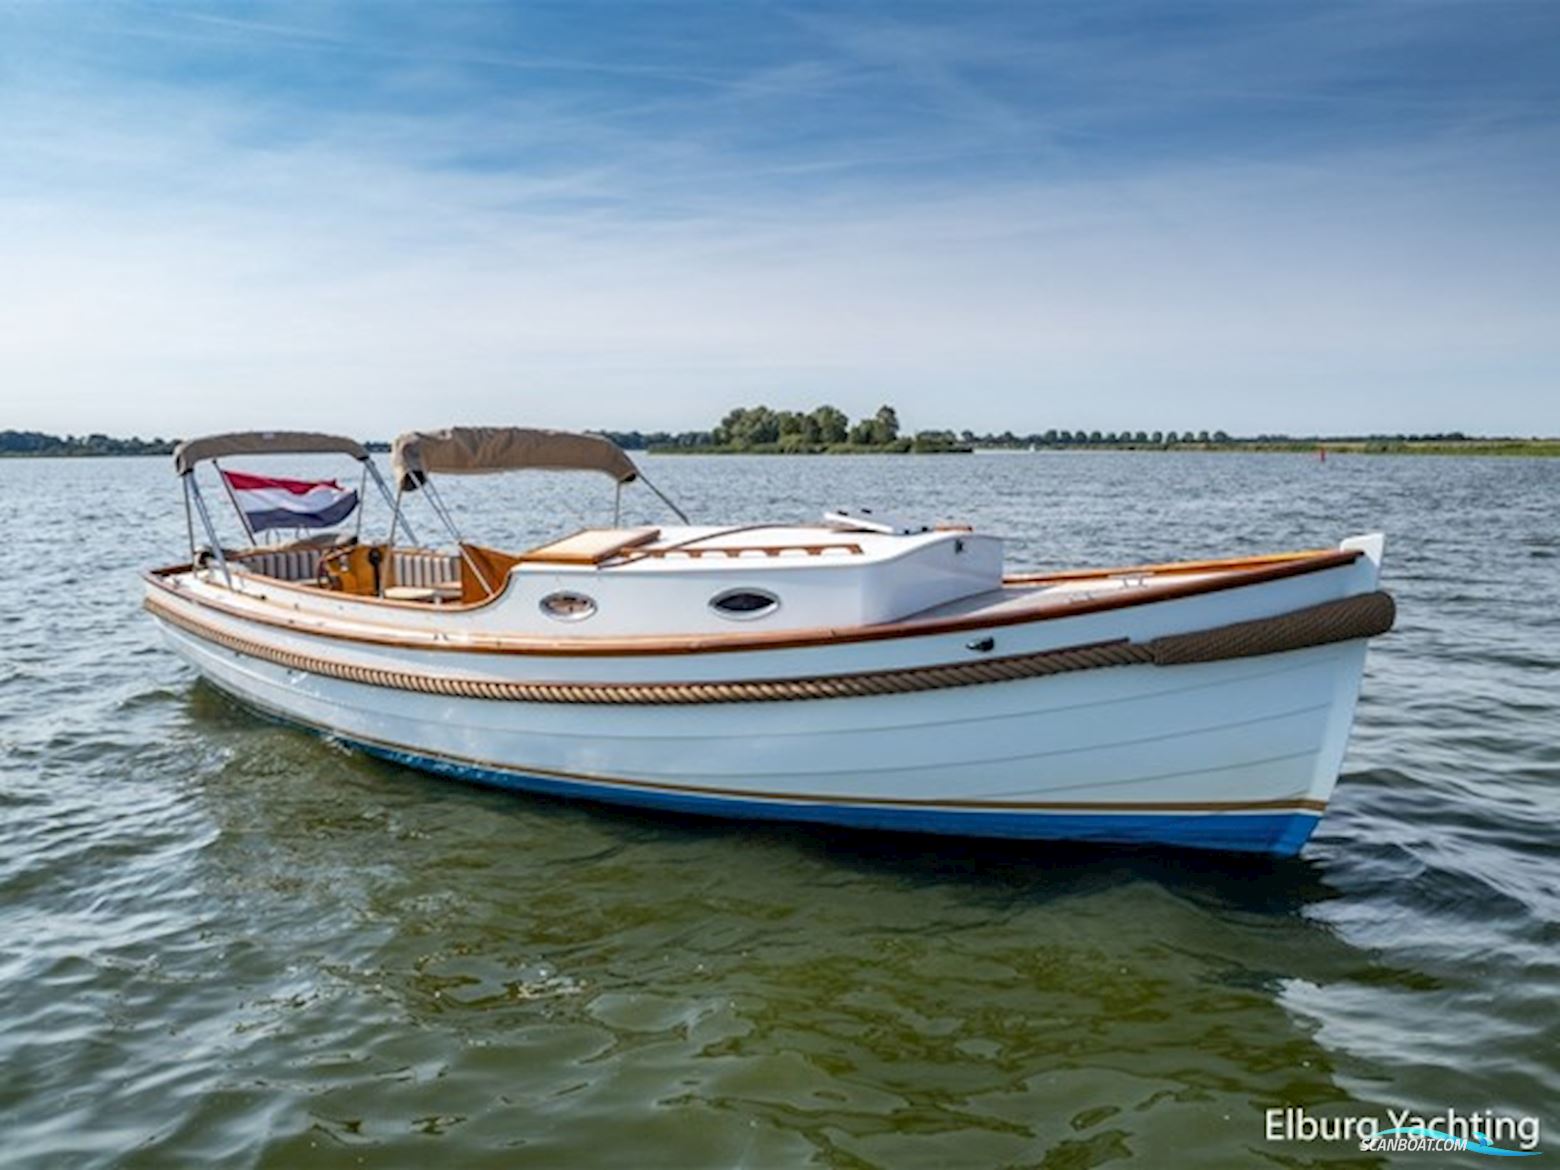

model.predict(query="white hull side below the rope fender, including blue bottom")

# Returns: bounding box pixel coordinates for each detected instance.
[143,599,1365,855]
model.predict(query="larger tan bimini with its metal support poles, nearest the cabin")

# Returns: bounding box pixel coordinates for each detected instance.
[388,426,688,593]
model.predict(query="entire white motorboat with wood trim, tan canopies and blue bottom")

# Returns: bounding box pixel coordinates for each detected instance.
[145,427,1393,853]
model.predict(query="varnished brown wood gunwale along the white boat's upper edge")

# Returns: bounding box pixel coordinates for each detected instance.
[144,549,1360,658]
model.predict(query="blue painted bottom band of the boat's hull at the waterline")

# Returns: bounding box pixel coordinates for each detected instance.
[188,679,1321,856]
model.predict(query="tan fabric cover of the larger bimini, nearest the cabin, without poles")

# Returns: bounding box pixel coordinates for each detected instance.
[390,426,640,491]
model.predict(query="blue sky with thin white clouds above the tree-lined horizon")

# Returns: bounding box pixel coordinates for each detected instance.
[0,0,1560,437]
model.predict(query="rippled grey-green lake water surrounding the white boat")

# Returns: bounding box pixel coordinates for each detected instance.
[0,454,1560,1170]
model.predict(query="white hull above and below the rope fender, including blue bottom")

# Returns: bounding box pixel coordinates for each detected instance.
[153,541,1381,853]
